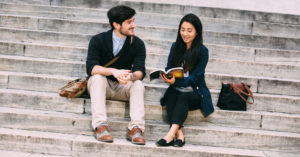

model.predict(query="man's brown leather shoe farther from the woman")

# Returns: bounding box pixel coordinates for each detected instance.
[95,125,114,142]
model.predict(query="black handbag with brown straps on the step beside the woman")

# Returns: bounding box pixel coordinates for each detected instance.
[217,82,254,111]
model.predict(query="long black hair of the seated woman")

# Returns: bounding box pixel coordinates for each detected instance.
[171,14,203,72]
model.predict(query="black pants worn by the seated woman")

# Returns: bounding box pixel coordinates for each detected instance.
[164,88,201,128]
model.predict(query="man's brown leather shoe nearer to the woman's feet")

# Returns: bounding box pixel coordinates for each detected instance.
[127,127,146,145]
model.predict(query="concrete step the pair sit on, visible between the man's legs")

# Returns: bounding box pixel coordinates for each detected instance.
[0,89,300,133]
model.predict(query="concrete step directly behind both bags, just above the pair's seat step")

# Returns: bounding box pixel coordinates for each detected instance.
[0,72,300,113]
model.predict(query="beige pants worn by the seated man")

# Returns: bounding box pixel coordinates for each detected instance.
[87,75,145,131]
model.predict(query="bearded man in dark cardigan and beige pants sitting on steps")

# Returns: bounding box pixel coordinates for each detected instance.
[86,5,146,145]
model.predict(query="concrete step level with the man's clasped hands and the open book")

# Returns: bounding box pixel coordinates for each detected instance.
[0,55,300,96]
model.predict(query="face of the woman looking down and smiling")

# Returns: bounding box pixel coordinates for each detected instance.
[180,22,197,48]
